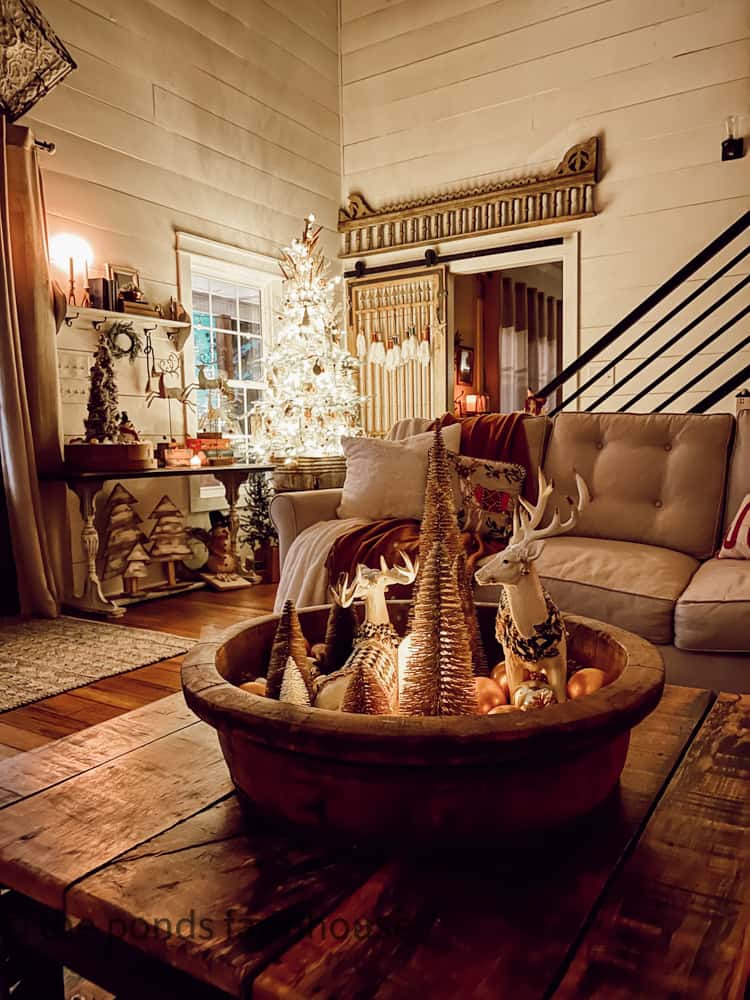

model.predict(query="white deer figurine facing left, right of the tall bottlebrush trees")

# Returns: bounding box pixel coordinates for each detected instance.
[474,469,590,702]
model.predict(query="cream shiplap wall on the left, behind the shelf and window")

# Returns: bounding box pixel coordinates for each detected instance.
[23,0,341,592]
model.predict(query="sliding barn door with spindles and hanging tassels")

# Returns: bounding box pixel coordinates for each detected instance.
[347,267,452,436]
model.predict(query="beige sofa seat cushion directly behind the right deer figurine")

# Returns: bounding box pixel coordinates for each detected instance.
[476,536,698,643]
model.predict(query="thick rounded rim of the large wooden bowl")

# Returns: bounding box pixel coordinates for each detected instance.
[182,605,664,765]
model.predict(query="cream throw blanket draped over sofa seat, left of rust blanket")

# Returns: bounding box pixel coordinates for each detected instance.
[273,517,369,614]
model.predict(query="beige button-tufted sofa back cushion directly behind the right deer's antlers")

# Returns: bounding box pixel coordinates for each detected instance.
[544,413,734,559]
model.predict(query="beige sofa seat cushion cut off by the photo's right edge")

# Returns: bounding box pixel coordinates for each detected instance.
[675,559,750,653]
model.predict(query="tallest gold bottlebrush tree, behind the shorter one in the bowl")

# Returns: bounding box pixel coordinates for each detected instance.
[418,427,489,675]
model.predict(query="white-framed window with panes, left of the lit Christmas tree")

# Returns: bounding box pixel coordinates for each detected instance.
[177,233,282,511]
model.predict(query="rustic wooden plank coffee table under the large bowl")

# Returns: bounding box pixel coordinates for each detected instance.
[0,687,750,1000]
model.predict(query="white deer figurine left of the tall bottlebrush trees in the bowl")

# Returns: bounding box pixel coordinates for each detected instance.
[315,553,419,711]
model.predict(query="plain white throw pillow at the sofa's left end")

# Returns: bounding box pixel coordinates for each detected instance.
[337,424,461,521]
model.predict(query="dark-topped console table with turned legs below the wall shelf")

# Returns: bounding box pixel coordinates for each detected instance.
[49,462,274,618]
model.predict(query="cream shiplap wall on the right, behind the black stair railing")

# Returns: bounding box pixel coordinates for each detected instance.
[341,0,750,408]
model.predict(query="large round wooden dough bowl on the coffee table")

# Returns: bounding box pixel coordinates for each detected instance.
[182,601,664,847]
